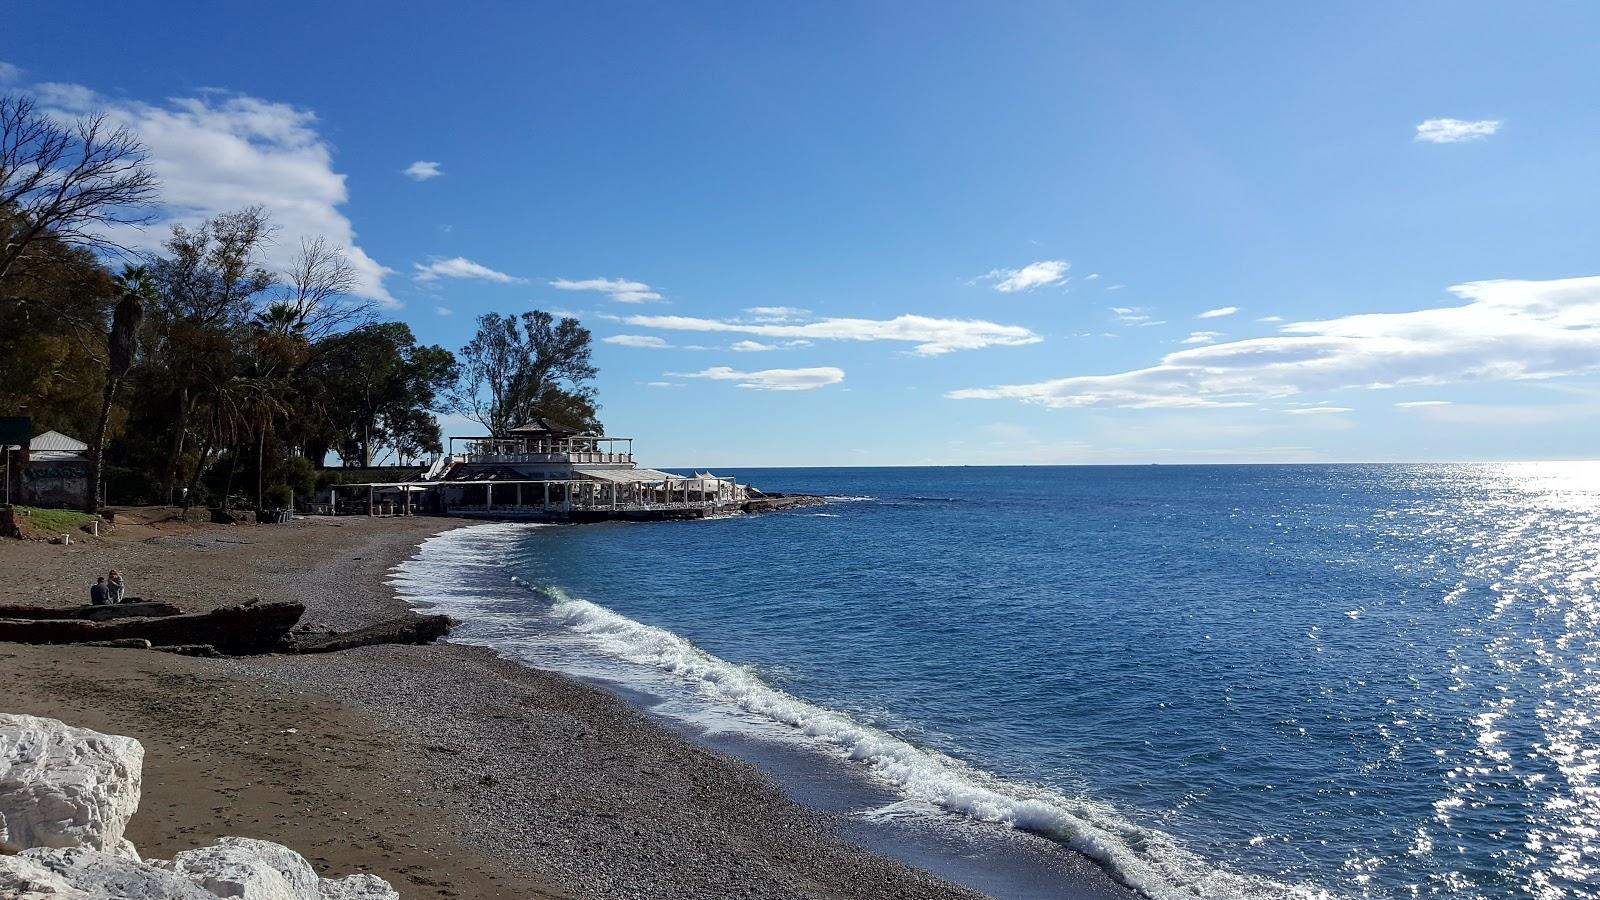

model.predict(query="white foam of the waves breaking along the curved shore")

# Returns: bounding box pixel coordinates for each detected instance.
[390,525,1331,900]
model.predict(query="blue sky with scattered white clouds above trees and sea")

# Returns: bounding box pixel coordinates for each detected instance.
[0,0,1600,468]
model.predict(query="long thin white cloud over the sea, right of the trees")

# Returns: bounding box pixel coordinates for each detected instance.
[622,315,1043,356]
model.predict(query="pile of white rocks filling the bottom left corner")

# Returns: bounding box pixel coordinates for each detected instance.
[0,713,400,900]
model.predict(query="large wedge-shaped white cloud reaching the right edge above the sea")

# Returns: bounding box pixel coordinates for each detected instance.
[947,275,1600,408]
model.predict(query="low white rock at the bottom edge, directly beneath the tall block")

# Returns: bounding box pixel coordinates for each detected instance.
[0,847,214,900]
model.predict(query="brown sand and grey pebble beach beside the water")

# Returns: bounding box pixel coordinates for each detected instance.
[0,517,974,898]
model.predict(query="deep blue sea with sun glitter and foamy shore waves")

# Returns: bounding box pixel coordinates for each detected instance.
[394,463,1600,900]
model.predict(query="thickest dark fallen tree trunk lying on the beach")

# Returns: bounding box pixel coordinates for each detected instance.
[0,604,306,657]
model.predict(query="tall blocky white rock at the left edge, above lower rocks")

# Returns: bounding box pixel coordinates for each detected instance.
[0,713,144,858]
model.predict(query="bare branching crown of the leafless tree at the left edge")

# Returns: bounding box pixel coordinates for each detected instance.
[0,96,157,280]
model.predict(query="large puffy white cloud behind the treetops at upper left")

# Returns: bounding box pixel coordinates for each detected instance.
[29,83,395,304]
